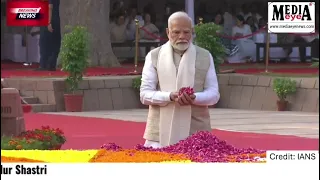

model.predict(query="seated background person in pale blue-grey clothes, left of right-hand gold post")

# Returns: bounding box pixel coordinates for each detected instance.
[232,15,256,62]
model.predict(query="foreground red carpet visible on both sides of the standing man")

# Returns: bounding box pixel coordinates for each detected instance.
[25,114,319,150]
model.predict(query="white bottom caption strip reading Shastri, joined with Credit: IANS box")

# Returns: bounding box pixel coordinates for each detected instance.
[1,151,319,180]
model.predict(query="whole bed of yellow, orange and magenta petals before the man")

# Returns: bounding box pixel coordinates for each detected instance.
[1,132,266,163]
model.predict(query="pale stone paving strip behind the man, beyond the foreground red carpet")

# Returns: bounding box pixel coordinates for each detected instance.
[46,109,319,138]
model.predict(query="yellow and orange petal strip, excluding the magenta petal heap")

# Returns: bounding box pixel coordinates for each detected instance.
[1,149,192,163]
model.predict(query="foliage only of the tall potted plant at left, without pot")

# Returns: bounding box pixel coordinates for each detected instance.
[60,26,89,93]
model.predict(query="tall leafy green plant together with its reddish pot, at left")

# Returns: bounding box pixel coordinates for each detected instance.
[60,26,89,112]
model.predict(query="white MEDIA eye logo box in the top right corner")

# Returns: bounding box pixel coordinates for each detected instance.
[268,2,316,33]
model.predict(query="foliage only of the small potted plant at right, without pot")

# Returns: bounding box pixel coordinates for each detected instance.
[273,78,297,101]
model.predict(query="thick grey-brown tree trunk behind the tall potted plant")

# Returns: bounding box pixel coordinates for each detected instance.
[60,0,120,67]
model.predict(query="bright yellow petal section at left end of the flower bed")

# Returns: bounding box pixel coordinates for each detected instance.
[1,150,98,163]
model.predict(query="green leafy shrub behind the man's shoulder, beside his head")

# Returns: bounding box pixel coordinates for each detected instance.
[194,23,225,73]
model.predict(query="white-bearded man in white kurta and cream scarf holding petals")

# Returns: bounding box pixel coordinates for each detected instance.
[140,12,220,148]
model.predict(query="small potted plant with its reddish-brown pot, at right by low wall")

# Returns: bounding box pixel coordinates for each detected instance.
[273,78,297,111]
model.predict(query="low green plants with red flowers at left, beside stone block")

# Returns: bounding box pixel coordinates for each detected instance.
[1,126,66,150]
